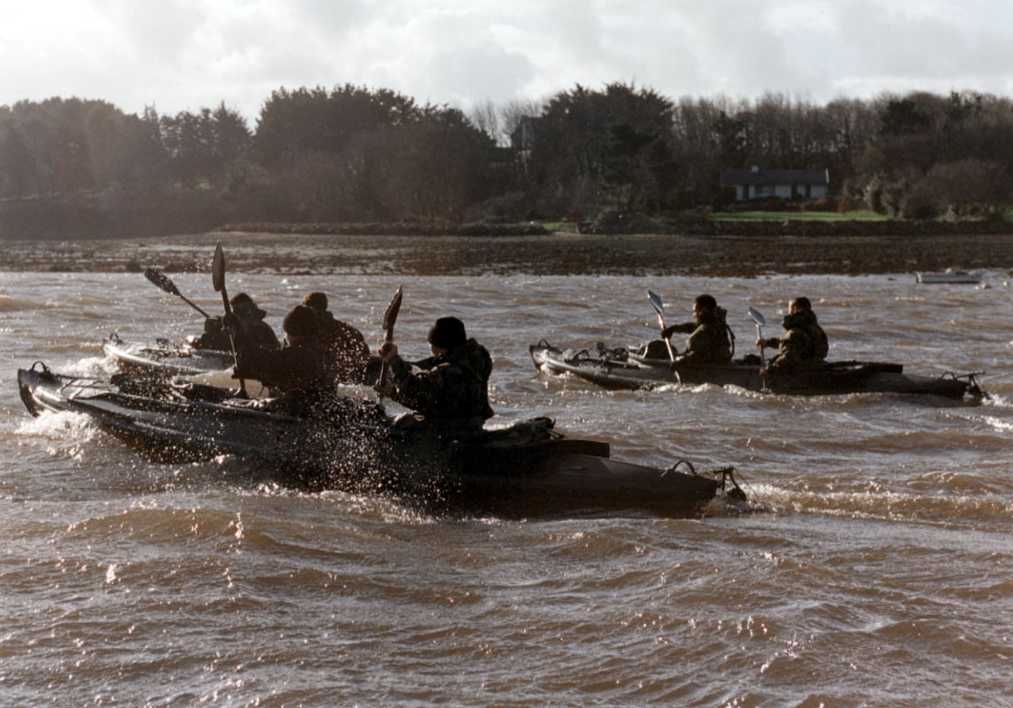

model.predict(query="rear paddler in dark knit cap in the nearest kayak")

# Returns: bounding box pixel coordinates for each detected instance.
[379,317,492,431]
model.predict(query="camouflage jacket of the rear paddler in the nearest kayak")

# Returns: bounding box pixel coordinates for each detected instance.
[390,339,492,425]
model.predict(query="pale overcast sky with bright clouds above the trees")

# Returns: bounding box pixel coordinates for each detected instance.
[0,0,1013,122]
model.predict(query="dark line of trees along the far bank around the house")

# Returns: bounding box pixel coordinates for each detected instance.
[0,83,1013,240]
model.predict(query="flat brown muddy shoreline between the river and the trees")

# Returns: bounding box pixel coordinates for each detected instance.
[0,231,1013,277]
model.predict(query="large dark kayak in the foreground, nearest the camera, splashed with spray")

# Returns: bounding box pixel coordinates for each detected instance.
[17,363,745,518]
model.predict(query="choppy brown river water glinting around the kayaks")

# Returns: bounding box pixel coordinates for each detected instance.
[0,273,1013,706]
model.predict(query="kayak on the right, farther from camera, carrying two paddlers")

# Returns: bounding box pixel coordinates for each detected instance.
[529,339,986,402]
